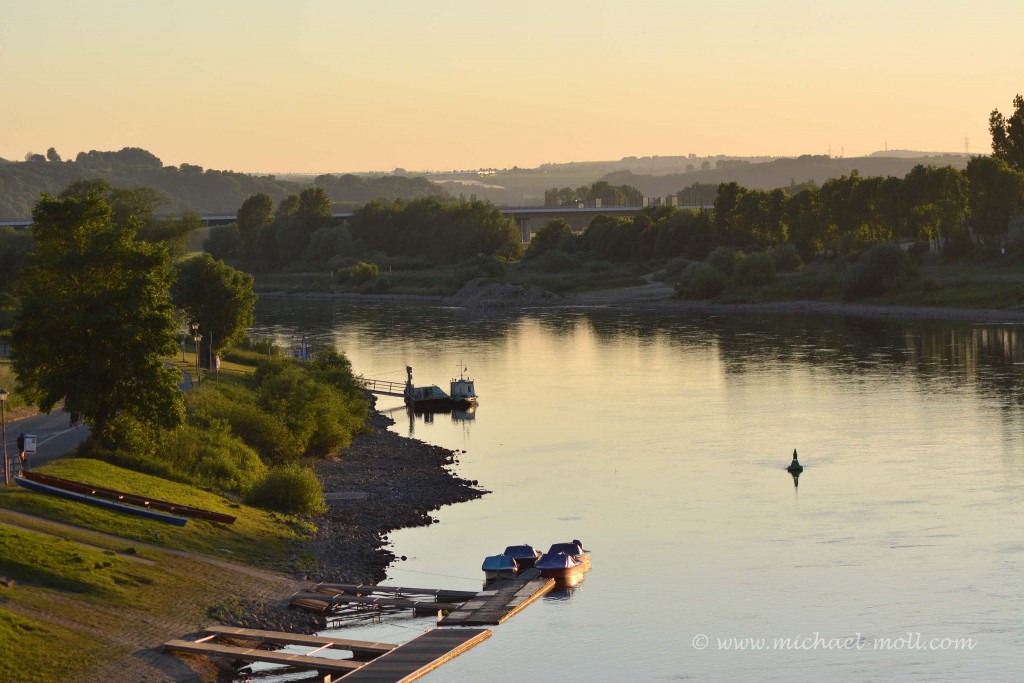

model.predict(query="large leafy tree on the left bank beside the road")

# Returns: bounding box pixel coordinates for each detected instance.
[11,187,184,444]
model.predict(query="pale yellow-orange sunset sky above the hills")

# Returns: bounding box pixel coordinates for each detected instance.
[0,0,1024,173]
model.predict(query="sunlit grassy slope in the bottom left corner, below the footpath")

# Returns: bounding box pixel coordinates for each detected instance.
[0,505,296,682]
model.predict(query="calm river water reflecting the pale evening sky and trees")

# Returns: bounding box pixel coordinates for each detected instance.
[249,301,1024,683]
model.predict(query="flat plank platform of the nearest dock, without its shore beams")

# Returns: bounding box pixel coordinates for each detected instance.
[335,629,490,683]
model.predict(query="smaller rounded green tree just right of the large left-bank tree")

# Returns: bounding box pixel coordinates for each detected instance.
[171,254,256,365]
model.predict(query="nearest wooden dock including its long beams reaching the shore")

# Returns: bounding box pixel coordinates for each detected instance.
[164,626,490,683]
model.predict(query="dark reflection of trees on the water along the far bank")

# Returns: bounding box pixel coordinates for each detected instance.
[256,300,1024,405]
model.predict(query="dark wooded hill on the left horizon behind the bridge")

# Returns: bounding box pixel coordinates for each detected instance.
[0,147,445,220]
